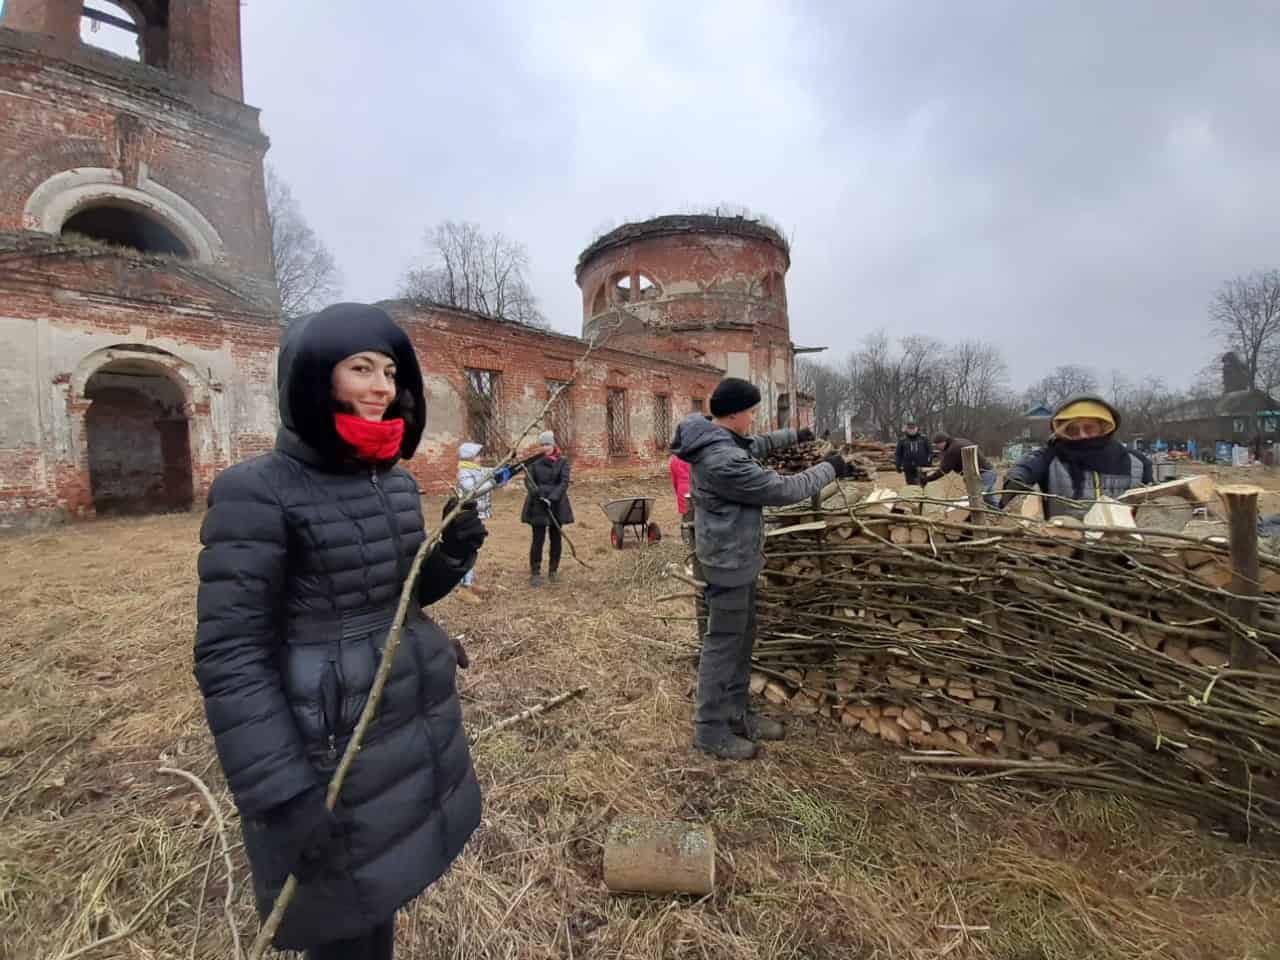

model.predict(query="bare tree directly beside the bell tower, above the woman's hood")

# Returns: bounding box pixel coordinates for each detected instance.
[266,166,342,323]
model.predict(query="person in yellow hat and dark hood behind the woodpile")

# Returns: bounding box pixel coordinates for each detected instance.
[1000,397,1153,520]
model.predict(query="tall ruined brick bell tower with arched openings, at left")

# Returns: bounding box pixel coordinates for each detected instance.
[0,0,279,527]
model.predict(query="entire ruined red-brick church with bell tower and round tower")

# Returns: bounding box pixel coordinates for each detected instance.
[0,0,812,527]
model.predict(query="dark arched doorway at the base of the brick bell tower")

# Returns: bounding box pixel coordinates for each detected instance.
[84,348,193,516]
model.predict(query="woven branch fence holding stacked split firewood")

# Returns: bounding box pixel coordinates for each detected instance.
[753,490,1280,833]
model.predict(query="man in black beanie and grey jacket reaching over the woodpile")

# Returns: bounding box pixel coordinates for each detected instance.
[671,376,851,760]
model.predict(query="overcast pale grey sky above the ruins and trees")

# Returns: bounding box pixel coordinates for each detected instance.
[243,0,1280,385]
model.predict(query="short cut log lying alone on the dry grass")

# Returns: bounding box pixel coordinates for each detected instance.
[604,814,716,896]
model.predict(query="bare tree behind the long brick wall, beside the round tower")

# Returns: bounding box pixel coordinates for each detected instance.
[401,220,548,328]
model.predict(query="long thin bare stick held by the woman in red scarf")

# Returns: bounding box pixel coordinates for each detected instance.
[248,321,612,960]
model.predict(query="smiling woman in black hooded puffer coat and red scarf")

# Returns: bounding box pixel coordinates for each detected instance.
[195,303,486,960]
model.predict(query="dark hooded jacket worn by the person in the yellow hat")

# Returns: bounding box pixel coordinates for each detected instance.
[1001,396,1153,518]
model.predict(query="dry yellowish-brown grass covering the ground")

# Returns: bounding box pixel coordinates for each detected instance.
[0,483,1280,960]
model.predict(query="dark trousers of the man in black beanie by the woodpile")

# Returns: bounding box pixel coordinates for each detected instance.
[694,581,755,744]
